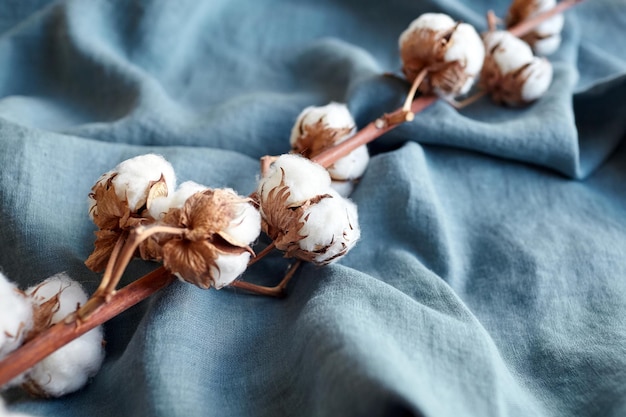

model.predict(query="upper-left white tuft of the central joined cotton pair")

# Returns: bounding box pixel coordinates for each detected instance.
[257,154,330,205]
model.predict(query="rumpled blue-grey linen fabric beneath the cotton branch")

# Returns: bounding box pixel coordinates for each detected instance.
[0,0,626,417]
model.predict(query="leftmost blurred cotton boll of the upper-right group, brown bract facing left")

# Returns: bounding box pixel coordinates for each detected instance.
[399,13,485,98]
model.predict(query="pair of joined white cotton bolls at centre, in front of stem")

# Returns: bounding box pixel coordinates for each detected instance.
[257,154,361,265]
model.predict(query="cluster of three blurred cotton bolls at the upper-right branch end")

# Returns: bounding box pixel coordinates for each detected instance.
[399,0,563,106]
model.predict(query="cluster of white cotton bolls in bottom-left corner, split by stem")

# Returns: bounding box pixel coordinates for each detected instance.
[0,273,104,397]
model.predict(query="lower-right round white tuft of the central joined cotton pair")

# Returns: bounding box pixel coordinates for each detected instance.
[298,190,361,264]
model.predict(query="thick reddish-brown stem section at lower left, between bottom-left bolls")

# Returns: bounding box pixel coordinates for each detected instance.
[0,267,175,386]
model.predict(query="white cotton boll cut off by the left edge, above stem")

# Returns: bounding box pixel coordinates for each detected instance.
[0,272,33,358]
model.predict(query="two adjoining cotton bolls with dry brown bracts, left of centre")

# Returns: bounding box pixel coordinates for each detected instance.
[86,154,261,288]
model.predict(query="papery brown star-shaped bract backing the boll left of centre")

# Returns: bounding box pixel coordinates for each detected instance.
[145,189,252,288]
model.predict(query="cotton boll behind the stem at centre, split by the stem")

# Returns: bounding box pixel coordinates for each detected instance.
[290,102,369,196]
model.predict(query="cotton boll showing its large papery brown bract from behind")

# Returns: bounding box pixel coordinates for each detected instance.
[150,188,261,289]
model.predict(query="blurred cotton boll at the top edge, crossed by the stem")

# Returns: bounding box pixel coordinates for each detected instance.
[506,0,565,56]
